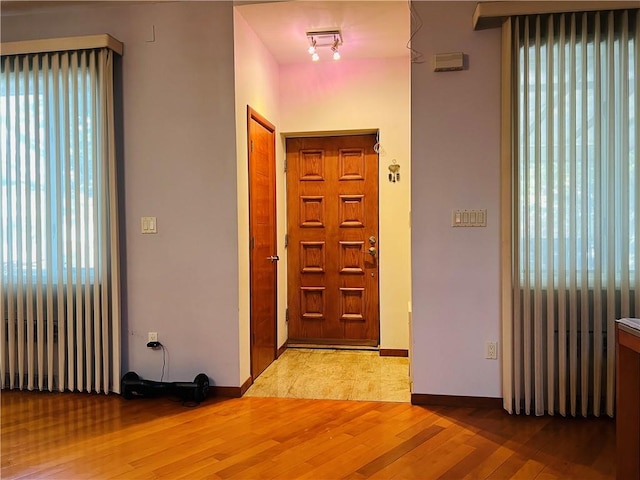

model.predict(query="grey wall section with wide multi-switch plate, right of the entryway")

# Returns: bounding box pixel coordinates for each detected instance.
[411,2,501,397]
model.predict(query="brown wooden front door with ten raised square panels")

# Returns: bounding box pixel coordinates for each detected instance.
[286,135,380,346]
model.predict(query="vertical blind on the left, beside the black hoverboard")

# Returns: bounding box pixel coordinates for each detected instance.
[0,48,120,392]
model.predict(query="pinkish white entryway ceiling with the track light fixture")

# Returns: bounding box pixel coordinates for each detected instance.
[236,0,410,64]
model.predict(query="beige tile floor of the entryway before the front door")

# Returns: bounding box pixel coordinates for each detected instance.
[245,348,411,402]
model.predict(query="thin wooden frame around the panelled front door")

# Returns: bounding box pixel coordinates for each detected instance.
[276,128,378,346]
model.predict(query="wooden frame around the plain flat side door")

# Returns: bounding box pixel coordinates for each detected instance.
[247,105,278,381]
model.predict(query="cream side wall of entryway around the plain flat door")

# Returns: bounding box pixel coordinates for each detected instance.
[234,9,287,382]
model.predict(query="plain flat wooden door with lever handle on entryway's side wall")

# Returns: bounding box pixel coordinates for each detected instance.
[247,108,278,379]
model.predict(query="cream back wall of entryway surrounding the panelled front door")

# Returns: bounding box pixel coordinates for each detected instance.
[280,56,412,349]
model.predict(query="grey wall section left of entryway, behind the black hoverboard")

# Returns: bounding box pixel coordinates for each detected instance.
[2,2,240,386]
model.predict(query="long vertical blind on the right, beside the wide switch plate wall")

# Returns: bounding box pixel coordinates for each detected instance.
[505,10,640,416]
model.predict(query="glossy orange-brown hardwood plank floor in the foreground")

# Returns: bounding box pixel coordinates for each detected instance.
[0,390,615,480]
